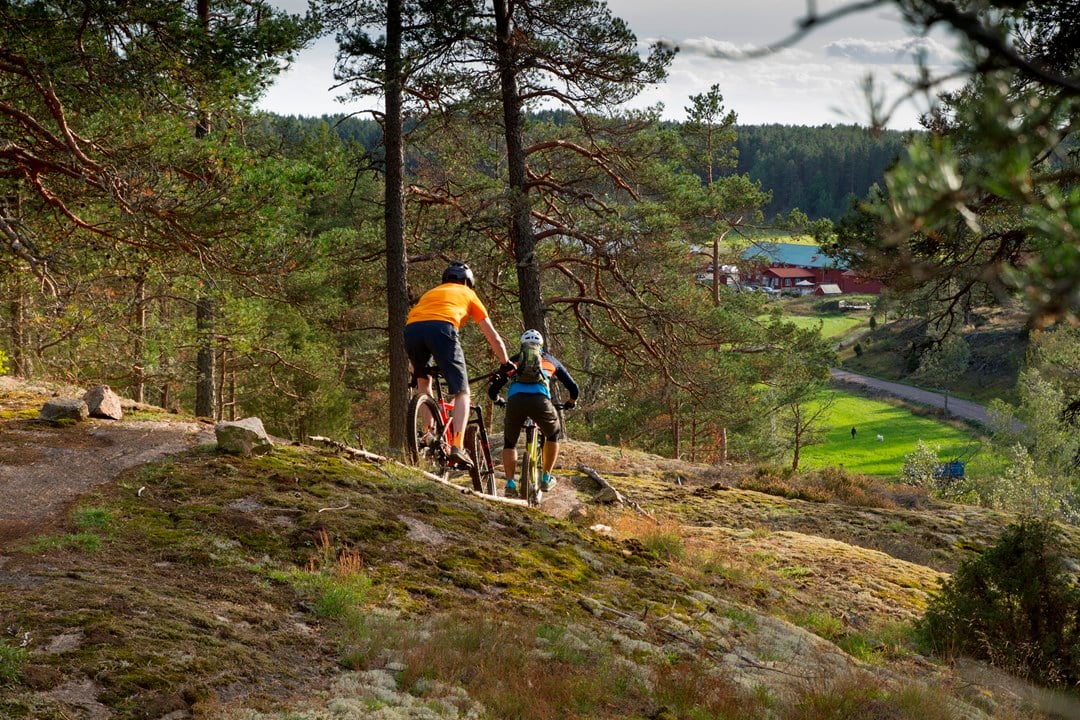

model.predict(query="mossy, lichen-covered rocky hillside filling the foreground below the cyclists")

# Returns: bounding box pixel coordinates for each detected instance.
[0,379,1077,720]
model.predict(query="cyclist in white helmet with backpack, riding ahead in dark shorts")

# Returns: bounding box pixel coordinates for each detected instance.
[487,330,580,495]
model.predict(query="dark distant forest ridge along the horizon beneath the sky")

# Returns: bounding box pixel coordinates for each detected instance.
[261,113,910,220]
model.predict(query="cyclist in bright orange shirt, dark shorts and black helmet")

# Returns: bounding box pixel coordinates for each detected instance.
[405,262,514,467]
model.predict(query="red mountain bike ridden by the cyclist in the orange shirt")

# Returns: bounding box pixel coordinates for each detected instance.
[405,366,496,495]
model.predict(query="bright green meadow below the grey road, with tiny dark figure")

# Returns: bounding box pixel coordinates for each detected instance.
[799,391,982,477]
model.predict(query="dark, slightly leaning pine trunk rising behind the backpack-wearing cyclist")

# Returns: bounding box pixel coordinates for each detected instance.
[494,0,548,337]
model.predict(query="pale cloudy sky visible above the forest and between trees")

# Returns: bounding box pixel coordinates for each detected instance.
[258,0,957,130]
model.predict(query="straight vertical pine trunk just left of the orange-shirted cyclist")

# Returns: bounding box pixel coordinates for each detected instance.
[382,0,409,453]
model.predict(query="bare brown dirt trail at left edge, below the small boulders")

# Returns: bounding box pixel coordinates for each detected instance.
[0,388,214,548]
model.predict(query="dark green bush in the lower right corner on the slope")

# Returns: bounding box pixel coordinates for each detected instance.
[921,518,1080,685]
